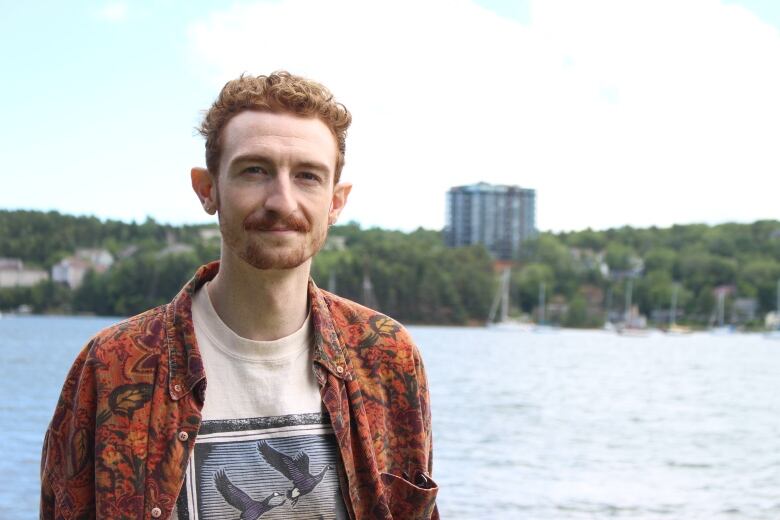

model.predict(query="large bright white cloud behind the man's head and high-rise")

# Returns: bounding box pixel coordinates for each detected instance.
[190,0,780,229]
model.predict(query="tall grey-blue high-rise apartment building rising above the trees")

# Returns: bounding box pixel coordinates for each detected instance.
[444,182,536,260]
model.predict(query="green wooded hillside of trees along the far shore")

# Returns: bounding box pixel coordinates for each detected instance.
[0,211,780,327]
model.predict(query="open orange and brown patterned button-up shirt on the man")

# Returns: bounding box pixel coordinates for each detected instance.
[40,262,438,520]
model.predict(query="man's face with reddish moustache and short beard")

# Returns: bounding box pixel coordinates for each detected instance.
[210,111,350,269]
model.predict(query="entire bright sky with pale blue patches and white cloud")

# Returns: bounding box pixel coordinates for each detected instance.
[0,0,780,231]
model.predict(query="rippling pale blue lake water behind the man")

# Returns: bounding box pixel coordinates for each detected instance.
[0,317,780,520]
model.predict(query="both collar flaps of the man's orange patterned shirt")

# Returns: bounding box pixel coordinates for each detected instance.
[165,261,352,400]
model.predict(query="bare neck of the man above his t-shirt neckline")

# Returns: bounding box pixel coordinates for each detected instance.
[208,248,311,341]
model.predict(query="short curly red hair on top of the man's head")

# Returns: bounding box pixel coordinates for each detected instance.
[198,70,352,182]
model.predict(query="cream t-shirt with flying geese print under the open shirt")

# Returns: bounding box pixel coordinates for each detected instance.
[177,287,347,520]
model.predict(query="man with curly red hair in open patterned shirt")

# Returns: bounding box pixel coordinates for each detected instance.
[41,72,438,520]
